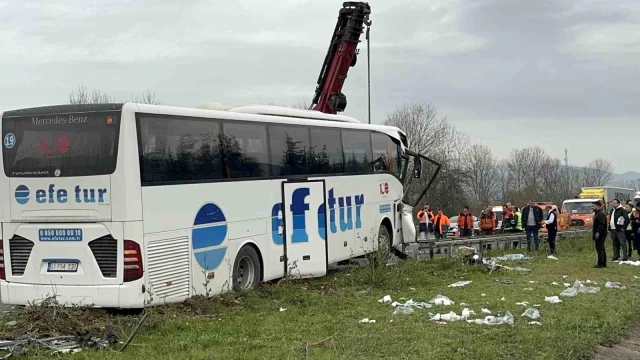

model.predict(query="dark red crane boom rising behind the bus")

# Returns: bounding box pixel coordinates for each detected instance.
[311,1,371,114]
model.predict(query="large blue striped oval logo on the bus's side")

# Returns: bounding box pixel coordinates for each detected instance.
[191,203,228,270]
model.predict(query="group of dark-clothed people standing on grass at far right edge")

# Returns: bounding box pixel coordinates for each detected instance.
[592,199,640,268]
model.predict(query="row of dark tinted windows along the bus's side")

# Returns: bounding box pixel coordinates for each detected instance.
[138,115,401,184]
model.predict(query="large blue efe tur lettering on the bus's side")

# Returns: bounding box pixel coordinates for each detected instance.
[271,187,364,245]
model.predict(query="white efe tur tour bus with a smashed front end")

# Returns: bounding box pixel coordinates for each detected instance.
[0,103,439,308]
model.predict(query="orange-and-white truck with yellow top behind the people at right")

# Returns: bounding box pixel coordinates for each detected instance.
[562,186,635,227]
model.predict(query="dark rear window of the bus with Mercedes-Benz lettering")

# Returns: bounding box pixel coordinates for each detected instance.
[2,112,120,177]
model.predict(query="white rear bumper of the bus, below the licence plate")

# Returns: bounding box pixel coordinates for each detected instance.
[0,280,145,309]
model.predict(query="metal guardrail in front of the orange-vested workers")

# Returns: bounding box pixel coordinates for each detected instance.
[418,228,591,259]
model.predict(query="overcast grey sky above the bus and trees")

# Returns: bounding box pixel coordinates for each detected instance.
[0,0,640,172]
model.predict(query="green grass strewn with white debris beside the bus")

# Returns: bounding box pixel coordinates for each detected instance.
[5,235,640,360]
